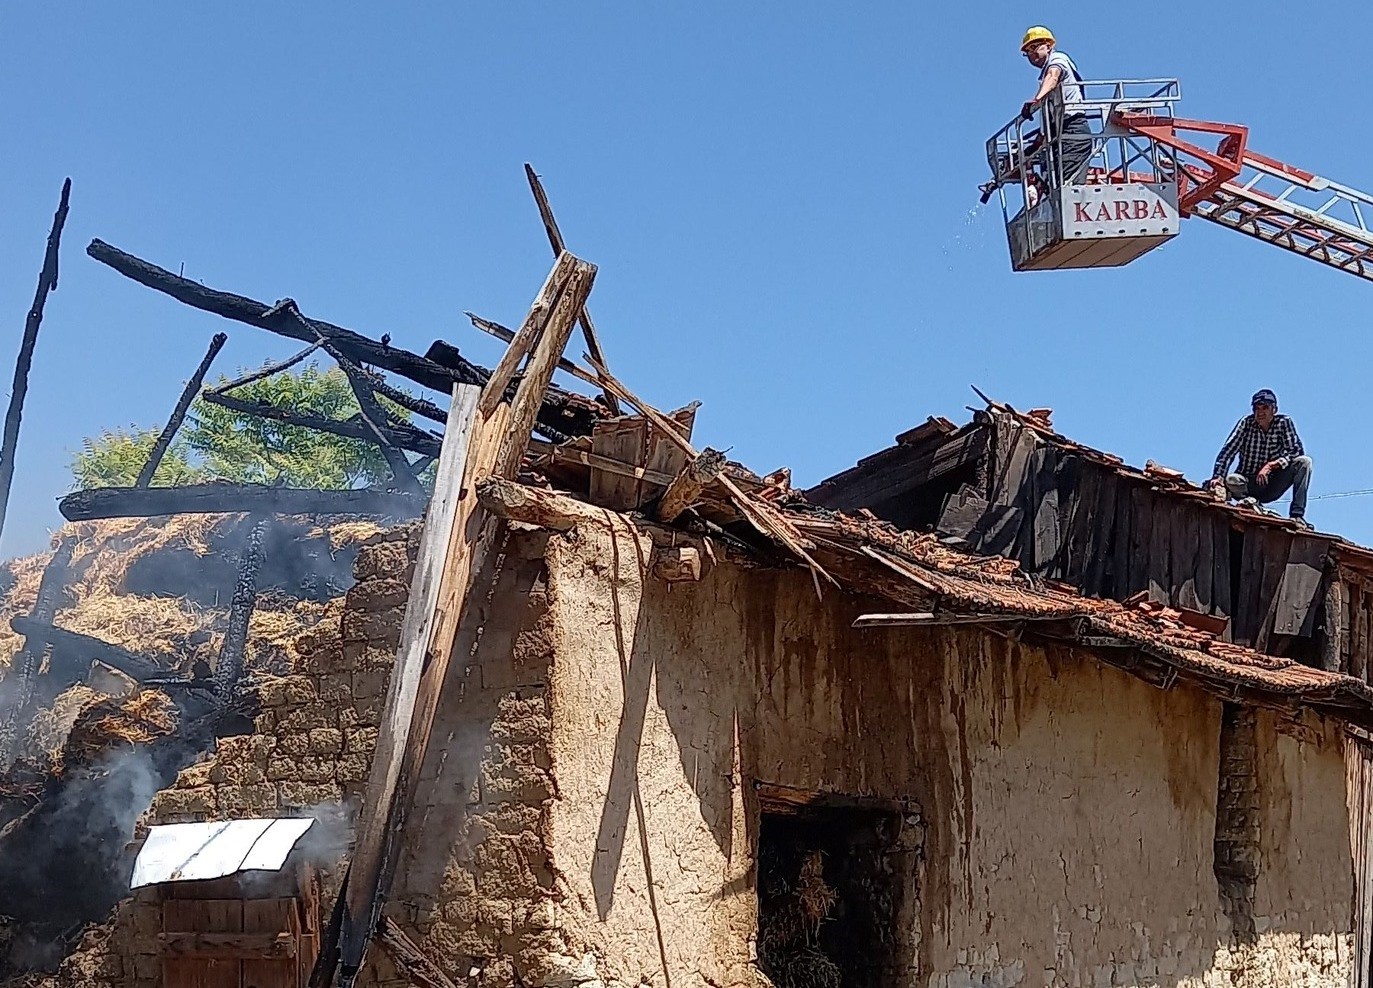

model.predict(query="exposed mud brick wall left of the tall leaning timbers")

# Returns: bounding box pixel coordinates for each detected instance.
[37,526,419,988]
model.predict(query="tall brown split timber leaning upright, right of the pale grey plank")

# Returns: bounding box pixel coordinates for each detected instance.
[339,254,596,988]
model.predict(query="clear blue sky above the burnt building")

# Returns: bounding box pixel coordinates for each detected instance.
[0,0,1373,554]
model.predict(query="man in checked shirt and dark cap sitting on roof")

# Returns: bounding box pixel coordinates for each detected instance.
[1210,388,1311,528]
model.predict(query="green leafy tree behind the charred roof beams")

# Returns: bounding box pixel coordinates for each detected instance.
[71,364,420,490]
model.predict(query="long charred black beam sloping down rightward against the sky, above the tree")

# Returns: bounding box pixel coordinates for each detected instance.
[86,240,486,394]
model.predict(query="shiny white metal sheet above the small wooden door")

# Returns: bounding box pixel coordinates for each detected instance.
[129,818,314,888]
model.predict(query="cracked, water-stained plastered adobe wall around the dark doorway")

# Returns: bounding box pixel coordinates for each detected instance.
[518,521,1352,988]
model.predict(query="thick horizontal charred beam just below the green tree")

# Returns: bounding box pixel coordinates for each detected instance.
[58,483,424,521]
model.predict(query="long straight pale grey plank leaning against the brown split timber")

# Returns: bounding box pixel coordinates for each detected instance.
[330,384,481,982]
